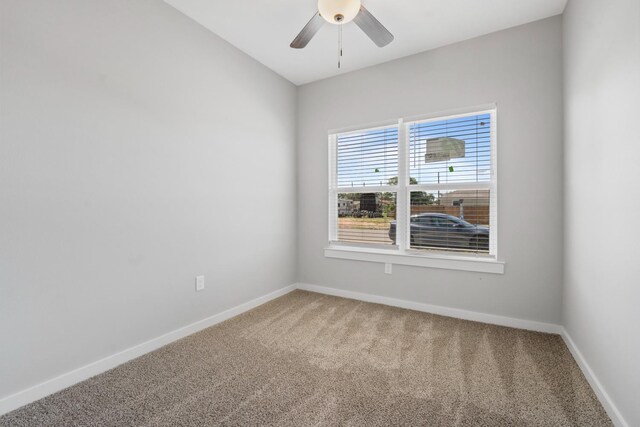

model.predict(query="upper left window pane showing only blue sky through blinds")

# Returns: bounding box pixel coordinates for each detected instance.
[337,127,398,187]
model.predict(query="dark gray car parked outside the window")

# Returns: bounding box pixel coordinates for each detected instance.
[389,213,489,251]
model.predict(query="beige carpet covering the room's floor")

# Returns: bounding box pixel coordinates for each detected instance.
[0,291,611,426]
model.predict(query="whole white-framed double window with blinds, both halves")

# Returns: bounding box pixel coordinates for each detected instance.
[325,106,497,274]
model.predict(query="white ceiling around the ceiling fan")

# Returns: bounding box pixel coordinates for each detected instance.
[165,0,567,85]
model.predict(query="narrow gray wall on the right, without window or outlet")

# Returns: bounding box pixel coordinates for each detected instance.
[563,0,640,426]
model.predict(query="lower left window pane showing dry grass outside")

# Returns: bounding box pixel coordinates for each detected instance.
[337,193,396,245]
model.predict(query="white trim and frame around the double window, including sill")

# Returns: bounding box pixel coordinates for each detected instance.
[324,104,505,274]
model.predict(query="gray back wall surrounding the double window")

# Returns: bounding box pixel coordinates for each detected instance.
[298,16,563,323]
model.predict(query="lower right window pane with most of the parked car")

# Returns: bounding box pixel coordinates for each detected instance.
[410,190,491,253]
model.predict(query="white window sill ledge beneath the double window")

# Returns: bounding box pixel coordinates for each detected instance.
[324,245,504,274]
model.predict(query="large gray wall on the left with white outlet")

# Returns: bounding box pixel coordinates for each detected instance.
[0,0,296,397]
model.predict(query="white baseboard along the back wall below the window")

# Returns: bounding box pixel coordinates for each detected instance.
[297,283,562,334]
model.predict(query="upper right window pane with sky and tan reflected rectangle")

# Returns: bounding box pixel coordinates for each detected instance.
[409,114,491,184]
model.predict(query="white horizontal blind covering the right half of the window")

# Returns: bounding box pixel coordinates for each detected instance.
[407,111,496,254]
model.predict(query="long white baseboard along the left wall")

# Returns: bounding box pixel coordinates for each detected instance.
[0,285,296,415]
